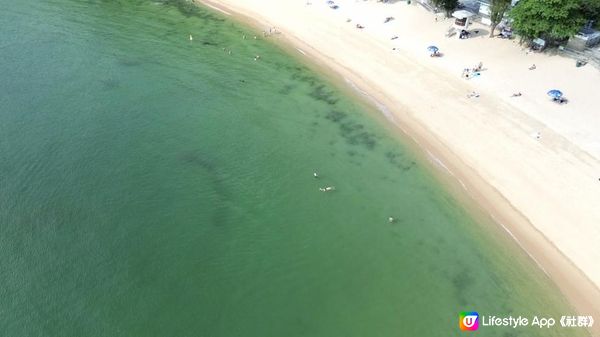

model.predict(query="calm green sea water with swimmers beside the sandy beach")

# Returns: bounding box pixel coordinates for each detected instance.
[0,0,583,337]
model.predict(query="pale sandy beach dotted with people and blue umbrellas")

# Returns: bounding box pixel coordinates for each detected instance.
[200,0,600,332]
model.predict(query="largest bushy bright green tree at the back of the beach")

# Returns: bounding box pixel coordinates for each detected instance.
[509,0,585,40]
